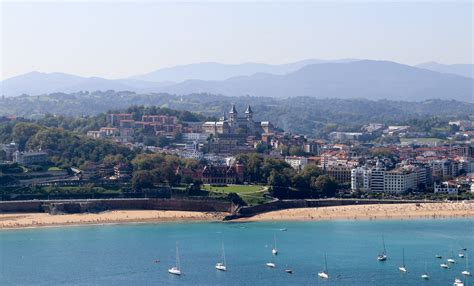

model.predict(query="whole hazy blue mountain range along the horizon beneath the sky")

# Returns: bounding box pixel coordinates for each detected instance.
[0,59,474,102]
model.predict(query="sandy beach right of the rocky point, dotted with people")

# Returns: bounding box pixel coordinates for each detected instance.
[239,202,474,221]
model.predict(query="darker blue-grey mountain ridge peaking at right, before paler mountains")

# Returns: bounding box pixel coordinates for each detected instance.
[156,60,474,101]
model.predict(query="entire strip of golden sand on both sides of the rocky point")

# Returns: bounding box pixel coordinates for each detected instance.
[0,202,474,230]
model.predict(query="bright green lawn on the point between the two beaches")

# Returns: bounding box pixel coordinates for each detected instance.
[202,185,268,205]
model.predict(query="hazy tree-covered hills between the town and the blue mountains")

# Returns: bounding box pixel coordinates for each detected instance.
[0,91,474,135]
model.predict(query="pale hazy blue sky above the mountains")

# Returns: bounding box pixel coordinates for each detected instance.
[0,1,473,79]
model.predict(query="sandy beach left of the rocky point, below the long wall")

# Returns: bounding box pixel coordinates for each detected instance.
[0,210,228,229]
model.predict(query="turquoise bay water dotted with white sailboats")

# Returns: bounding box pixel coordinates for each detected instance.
[0,219,474,286]
